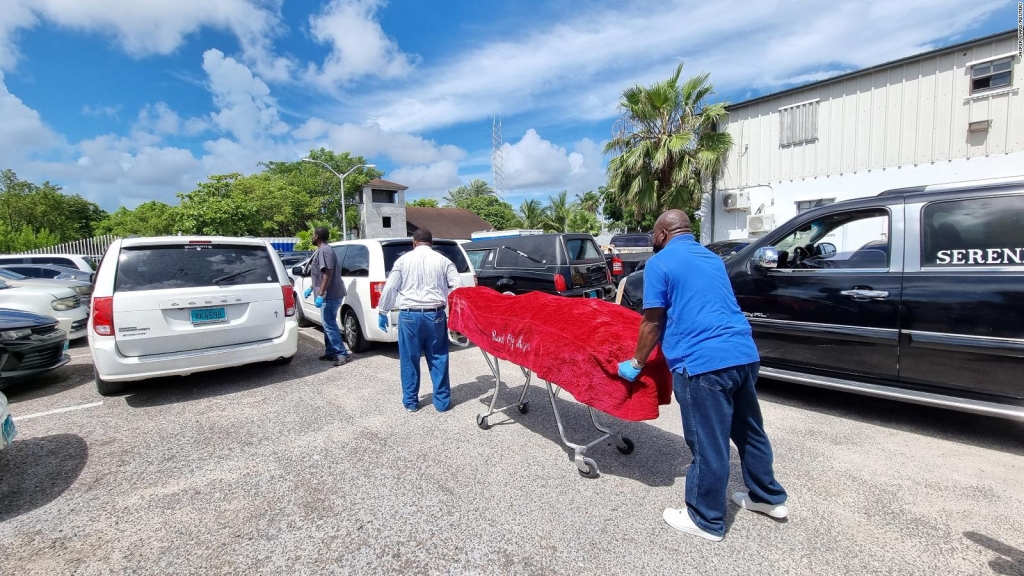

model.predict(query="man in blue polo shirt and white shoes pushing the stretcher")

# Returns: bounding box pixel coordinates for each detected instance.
[618,210,788,541]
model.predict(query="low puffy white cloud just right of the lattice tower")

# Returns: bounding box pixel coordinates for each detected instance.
[502,128,605,193]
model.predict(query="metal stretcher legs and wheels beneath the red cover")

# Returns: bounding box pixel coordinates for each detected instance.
[449,331,635,478]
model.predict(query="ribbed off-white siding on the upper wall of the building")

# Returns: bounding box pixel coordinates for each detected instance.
[720,36,1024,189]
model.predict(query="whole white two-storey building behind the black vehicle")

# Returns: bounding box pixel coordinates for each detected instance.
[701,30,1024,243]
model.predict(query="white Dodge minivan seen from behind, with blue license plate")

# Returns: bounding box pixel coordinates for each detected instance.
[89,236,298,395]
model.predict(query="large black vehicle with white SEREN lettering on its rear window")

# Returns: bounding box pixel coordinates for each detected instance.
[623,177,1024,420]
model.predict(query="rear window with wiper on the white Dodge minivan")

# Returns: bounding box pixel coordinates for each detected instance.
[115,244,278,292]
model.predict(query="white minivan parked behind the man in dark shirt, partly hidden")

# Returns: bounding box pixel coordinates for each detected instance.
[291,238,476,352]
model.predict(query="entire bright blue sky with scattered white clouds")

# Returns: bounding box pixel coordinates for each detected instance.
[0,0,1017,210]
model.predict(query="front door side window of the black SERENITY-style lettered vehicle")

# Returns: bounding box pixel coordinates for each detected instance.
[775,209,891,270]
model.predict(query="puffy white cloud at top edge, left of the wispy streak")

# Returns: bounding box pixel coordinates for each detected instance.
[305,0,418,87]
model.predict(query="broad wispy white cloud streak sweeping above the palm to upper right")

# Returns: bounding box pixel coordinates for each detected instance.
[358,0,1007,131]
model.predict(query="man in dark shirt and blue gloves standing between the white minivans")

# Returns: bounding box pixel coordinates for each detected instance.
[304,227,348,366]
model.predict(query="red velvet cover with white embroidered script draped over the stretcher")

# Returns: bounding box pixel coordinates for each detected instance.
[449,287,672,421]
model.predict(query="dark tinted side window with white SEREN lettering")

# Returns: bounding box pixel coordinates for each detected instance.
[921,195,1024,268]
